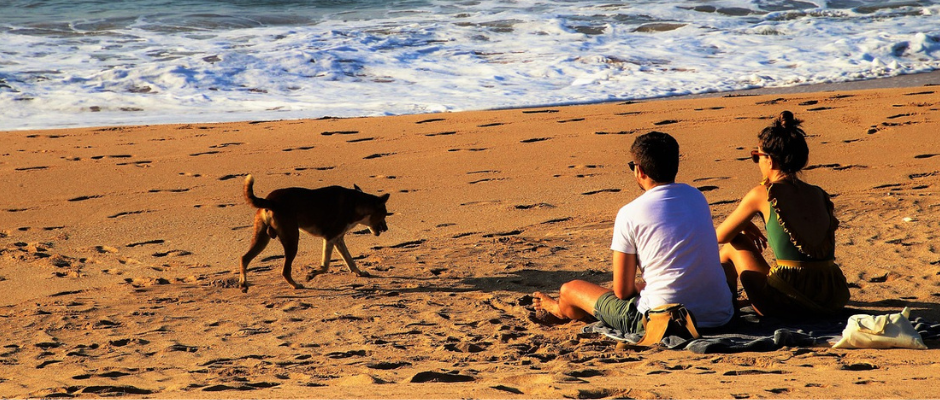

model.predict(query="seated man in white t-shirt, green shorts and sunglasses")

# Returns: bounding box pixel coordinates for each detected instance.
[534,132,734,334]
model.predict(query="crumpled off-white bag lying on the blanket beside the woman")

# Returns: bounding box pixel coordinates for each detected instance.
[832,307,927,350]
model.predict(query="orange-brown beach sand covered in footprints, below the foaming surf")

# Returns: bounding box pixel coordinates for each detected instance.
[0,83,940,398]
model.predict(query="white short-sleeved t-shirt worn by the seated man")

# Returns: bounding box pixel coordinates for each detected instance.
[610,183,734,328]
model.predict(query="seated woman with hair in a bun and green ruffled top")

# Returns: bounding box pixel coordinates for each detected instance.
[716,111,849,316]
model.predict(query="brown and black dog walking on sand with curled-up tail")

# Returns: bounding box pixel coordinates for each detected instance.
[238,175,390,292]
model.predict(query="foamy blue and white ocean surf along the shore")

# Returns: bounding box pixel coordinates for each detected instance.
[0,0,940,130]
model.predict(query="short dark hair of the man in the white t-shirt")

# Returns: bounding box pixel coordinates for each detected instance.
[630,131,679,183]
